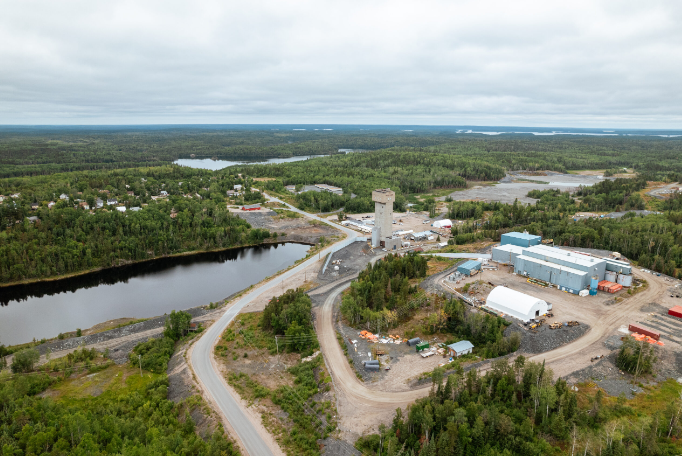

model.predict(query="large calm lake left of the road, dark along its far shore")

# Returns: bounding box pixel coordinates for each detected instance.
[0,243,310,345]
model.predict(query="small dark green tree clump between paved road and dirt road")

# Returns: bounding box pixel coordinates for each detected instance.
[261,288,317,352]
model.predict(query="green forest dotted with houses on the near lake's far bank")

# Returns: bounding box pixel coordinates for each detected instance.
[0,167,270,283]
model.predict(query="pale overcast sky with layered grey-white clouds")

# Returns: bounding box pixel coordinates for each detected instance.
[0,0,682,129]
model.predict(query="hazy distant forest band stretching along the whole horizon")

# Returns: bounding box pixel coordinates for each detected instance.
[0,126,682,177]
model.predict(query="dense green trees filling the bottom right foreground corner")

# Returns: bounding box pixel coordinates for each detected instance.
[356,356,682,456]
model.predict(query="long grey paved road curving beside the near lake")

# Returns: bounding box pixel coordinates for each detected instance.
[190,195,358,456]
